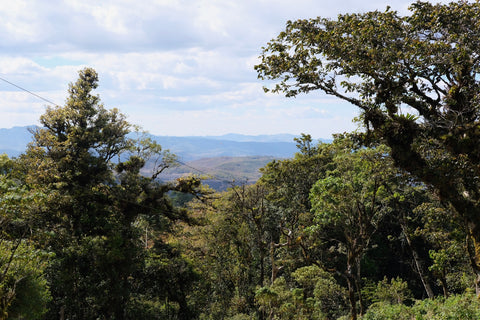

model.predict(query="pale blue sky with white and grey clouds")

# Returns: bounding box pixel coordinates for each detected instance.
[0,0,428,138]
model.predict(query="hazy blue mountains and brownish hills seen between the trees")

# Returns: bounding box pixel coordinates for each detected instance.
[0,126,331,190]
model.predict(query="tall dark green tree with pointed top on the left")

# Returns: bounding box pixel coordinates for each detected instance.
[23,69,139,319]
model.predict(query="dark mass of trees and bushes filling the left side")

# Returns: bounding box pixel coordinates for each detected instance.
[0,69,204,319]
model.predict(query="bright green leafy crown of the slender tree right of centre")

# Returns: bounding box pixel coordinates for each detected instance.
[310,140,394,232]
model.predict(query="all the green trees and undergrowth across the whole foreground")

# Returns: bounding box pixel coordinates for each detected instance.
[0,2,480,320]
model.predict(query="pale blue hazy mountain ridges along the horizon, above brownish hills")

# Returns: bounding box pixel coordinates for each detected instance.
[0,126,332,162]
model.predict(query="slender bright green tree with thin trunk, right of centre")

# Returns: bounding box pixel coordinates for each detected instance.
[309,139,395,319]
